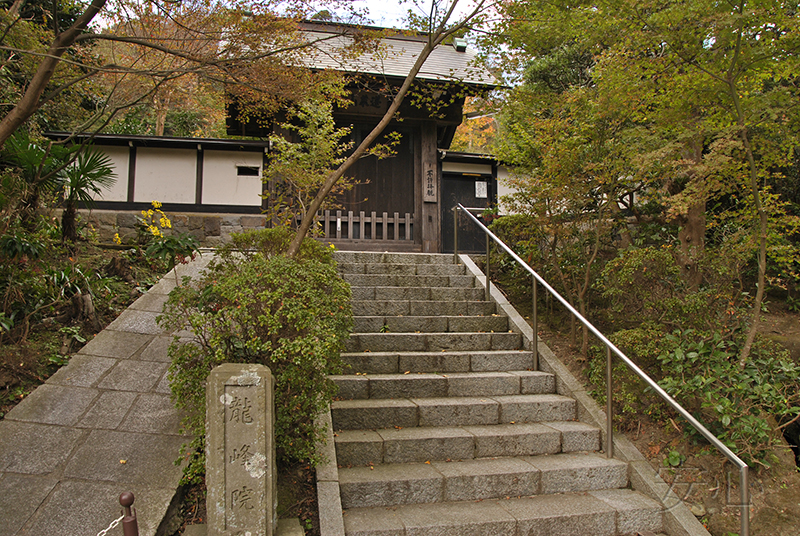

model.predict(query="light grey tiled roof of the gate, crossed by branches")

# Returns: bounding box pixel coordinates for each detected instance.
[305,28,501,87]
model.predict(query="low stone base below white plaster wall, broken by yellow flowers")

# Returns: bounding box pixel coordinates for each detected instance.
[80,210,267,247]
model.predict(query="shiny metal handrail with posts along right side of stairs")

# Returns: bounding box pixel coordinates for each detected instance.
[452,203,750,536]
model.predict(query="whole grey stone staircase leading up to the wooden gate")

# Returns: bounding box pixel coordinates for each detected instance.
[331,252,665,536]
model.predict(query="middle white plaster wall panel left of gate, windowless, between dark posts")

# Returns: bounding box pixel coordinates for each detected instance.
[133,147,197,203]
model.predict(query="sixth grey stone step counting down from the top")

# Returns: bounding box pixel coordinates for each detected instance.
[353,315,508,333]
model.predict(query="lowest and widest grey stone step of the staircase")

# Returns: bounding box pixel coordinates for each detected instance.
[344,489,663,536]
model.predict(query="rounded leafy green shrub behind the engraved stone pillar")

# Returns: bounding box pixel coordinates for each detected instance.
[159,229,352,480]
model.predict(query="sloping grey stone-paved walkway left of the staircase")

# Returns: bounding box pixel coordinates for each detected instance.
[0,253,212,536]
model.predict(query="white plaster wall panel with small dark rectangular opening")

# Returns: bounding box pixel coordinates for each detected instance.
[203,151,262,206]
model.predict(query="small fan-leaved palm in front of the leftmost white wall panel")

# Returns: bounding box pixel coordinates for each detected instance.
[59,149,117,242]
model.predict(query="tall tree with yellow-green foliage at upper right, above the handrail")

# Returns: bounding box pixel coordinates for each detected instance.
[488,0,800,364]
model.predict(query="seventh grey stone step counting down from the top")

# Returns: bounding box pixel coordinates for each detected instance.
[345,332,522,352]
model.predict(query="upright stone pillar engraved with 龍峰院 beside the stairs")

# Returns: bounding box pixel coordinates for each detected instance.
[206,363,278,536]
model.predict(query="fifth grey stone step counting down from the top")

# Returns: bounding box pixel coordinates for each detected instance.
[352,300,497,316]
